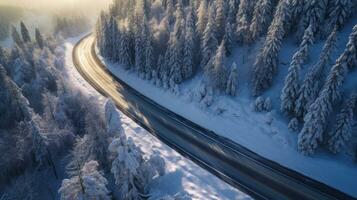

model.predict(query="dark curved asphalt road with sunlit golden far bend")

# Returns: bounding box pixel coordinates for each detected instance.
[73,35,353,200]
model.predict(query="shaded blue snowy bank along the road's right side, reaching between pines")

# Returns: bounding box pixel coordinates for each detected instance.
[96,18,357,197]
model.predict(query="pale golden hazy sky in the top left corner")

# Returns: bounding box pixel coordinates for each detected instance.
[0,0,112,14]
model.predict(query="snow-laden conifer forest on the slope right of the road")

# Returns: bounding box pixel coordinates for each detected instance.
[96,0,357,155]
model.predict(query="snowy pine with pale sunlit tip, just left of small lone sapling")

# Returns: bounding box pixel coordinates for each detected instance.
[209,41,227,90]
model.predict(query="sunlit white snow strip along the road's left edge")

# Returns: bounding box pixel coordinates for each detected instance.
[65,37,251,200]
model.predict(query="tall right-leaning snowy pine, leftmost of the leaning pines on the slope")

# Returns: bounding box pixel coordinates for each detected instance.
[252,0,291,96]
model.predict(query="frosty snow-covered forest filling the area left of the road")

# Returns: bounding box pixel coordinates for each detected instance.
[0,19,184,200]
